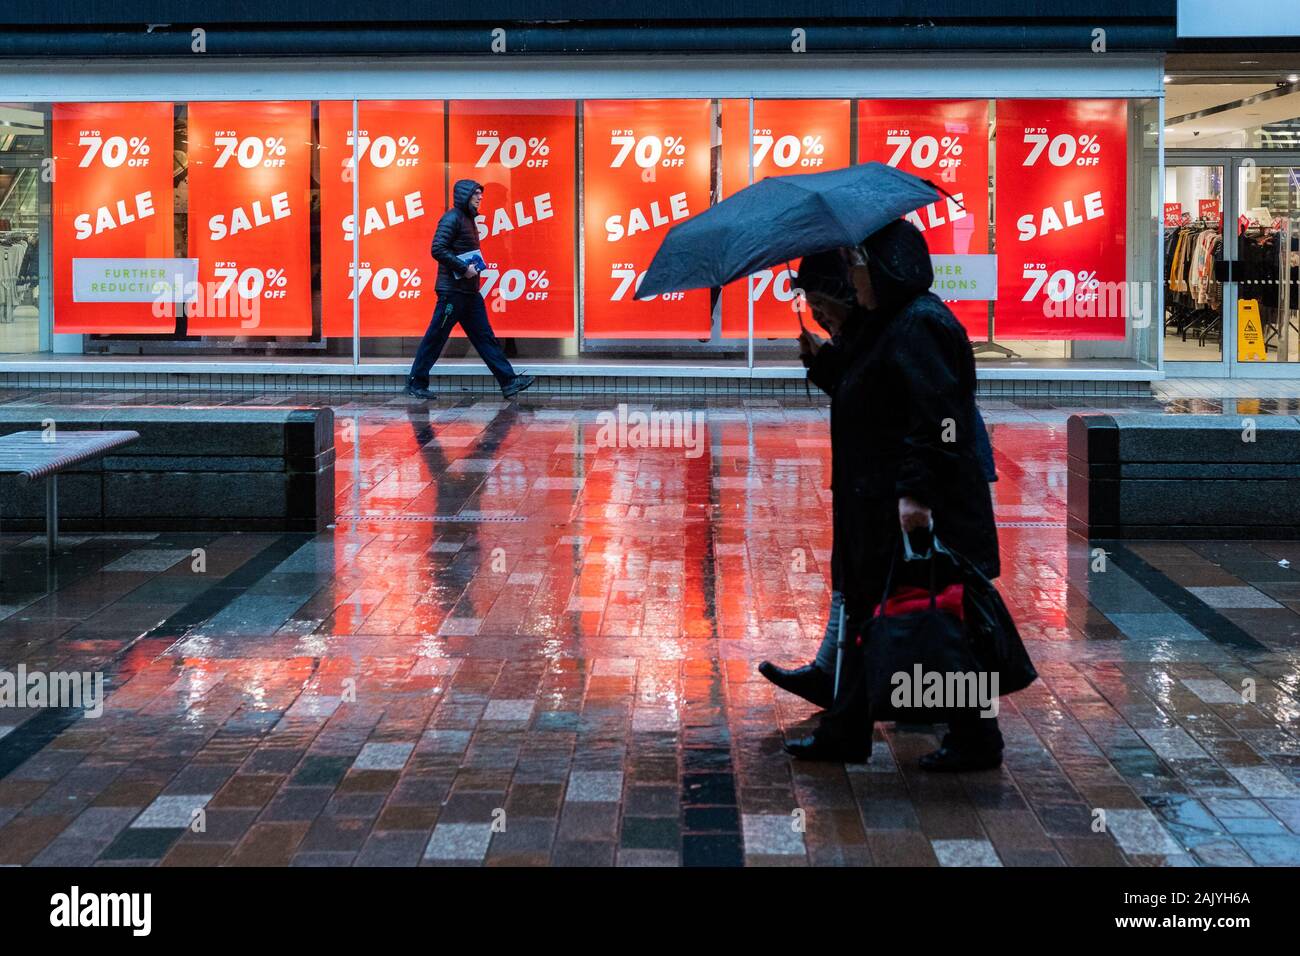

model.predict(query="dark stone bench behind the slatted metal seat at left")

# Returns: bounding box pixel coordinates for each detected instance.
[0,405,334,532]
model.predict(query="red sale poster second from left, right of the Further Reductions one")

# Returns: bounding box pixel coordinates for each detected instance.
[187,101,312,336]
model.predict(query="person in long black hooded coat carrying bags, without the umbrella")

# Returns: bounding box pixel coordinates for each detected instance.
[787,220,1002,770]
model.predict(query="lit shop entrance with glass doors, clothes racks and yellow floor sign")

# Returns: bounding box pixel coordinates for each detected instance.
[1162,0,1300,378]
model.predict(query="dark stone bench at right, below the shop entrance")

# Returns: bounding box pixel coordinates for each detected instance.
[1067,414,1300,538]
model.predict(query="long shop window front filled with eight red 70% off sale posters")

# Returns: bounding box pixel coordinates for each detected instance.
[0,7,1180,381]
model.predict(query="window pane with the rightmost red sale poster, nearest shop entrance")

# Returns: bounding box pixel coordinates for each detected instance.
[975,99,1160,368]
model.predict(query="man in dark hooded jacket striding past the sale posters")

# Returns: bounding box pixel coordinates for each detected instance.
[407,179,533,399]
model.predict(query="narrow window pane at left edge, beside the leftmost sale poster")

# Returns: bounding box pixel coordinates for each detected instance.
[0,103,51,354]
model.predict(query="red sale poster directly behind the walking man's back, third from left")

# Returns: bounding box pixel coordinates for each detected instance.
[320,100,446,337]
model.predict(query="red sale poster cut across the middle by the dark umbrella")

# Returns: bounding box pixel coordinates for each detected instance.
[722,100,850,338]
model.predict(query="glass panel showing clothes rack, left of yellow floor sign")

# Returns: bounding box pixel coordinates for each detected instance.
[1164,165,1223,362]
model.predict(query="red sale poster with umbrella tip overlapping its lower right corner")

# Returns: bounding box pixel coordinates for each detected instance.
[582,100,711,338]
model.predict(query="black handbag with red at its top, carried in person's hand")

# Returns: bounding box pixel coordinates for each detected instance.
[862,542,996,723]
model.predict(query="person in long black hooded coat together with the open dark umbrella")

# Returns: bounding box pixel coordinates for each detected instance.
[636,163,1001,770]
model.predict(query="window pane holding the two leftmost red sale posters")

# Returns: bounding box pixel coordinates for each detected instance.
[52,100,351,362]
